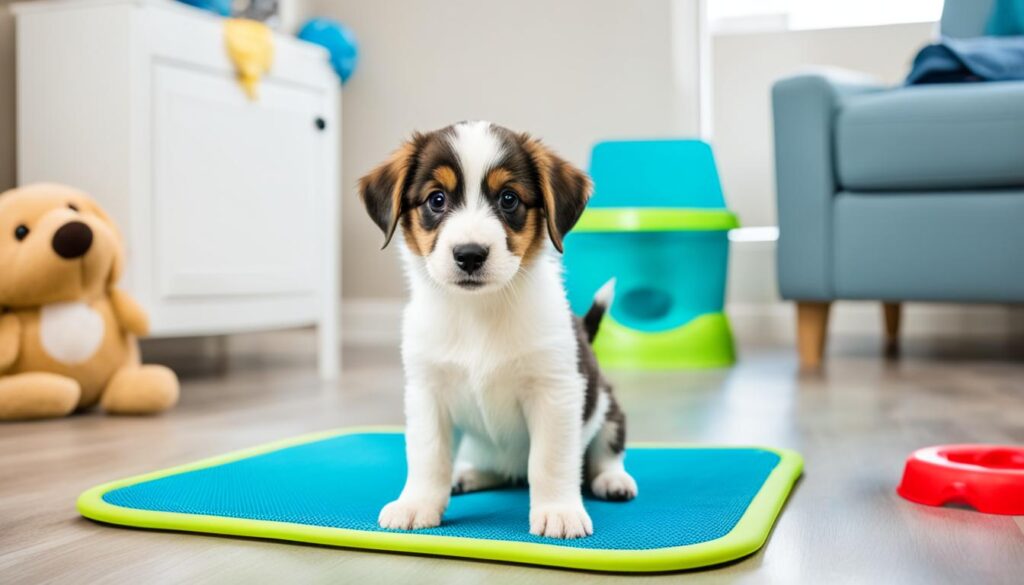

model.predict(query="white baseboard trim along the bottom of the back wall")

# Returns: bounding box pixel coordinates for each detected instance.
[341,299,1024,346]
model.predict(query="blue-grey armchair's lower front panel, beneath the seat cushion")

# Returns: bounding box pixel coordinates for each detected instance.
[833,190,1024,302]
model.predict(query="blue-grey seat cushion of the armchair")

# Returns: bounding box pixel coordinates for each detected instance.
[836,82,1024,192]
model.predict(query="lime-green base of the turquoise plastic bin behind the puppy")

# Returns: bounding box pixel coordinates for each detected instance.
[594,312,736,370]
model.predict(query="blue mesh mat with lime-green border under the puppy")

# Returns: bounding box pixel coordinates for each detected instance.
[79,428,802,572]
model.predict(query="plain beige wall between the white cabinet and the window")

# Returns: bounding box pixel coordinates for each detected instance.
[309,0,696,299]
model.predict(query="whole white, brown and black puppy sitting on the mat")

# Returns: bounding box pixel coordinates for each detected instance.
[359,122,637,538]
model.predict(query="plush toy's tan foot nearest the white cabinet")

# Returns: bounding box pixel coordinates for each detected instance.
[99,366,178,415]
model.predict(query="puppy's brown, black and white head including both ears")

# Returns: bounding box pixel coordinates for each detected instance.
[359,122,591,292]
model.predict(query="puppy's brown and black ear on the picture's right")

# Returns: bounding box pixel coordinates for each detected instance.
[519,134,593,252]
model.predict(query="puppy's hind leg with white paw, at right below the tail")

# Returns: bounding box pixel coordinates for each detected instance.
[587,395,638,502]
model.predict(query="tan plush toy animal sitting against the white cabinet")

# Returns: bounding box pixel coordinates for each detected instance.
[0,184,178,420]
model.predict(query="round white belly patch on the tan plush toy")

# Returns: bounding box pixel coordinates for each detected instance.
[39,301,105,365]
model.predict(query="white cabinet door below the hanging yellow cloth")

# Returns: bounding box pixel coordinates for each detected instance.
[153,62,330,300]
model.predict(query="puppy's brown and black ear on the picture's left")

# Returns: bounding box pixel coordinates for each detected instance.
[359,132,424,249]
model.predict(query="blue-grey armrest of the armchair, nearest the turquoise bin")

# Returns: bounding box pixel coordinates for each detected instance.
[772,71,885,300]
